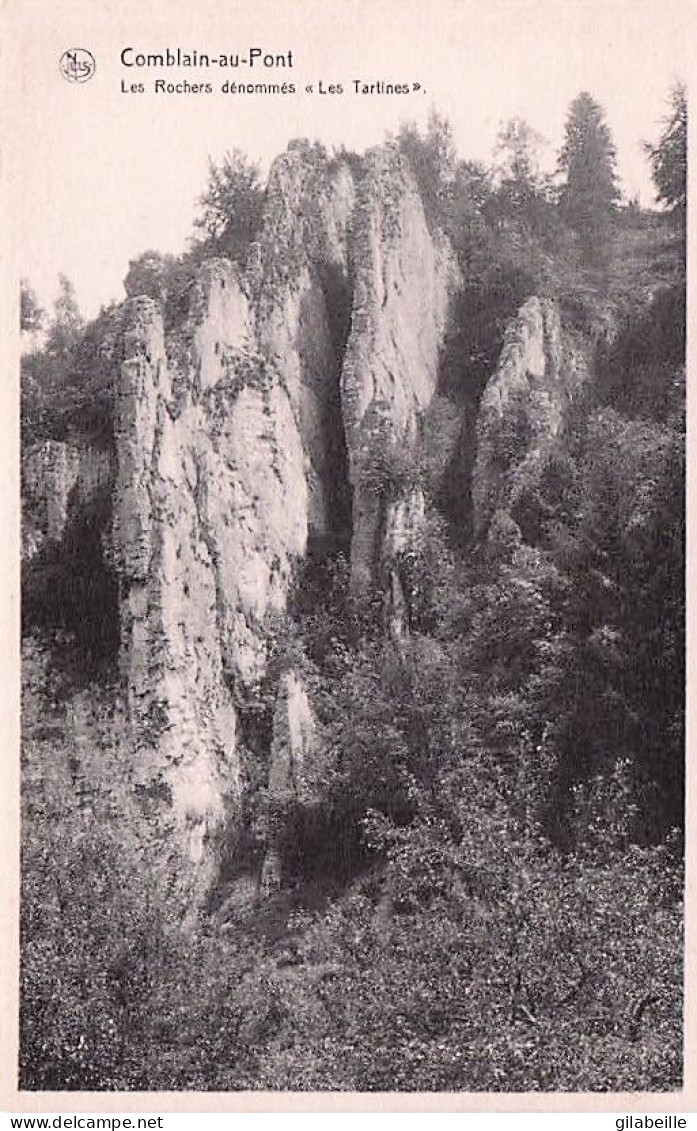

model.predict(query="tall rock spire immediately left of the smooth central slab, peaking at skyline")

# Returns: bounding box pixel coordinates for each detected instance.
[248,146,355,537]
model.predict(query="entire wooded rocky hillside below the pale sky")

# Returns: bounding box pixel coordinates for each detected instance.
[20,104,685,1090]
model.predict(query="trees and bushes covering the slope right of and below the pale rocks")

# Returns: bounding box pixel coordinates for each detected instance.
[20,83,685,1090]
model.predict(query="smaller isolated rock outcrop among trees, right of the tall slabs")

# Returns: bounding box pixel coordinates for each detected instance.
[472,296,585,534]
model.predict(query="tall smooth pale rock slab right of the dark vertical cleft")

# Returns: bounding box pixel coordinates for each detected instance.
[342,148,459,590]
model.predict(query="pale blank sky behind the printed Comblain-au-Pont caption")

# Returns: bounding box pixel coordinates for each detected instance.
[6,0,696,317]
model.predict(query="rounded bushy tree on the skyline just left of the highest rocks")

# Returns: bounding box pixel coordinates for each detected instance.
[193,149,264,264]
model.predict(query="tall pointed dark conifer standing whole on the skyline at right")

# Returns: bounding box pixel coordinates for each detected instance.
[558,90,619,261]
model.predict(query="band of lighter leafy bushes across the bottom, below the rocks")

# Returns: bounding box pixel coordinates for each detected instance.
[21,640,682,1090]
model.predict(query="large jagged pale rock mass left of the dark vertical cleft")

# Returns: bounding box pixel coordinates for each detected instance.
[114,149,353,873]
